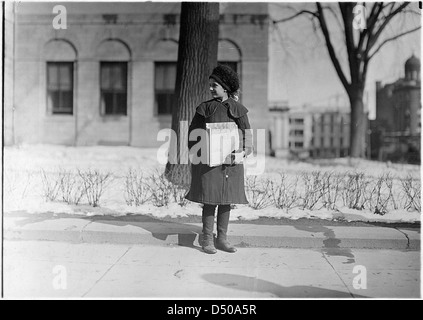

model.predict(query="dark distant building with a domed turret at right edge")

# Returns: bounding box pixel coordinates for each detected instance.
[371,55,421,163]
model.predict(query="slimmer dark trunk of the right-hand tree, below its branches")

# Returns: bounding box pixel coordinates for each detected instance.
[348,87,367,158]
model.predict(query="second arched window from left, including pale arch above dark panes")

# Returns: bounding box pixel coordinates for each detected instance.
[96,39,131,116]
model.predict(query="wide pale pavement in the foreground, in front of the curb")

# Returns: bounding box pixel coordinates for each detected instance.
[4,241,420,298]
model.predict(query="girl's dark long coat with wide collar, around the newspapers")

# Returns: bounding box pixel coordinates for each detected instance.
[186,98,252,205]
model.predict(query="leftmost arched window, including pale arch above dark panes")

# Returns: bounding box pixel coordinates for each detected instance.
[43,40,77,115]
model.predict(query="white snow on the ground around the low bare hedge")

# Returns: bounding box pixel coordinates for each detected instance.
[3,145,421,222]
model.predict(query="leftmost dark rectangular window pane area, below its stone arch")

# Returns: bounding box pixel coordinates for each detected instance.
[47,62,73,114]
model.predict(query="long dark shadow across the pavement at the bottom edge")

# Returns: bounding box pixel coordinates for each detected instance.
[203,273,368,299]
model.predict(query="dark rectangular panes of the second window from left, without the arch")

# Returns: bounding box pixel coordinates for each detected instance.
[100,62,128,116]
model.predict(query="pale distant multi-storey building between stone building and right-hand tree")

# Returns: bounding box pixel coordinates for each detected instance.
[270,103,350,159]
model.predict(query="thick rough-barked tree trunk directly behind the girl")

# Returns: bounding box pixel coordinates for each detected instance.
[165,2,219,185]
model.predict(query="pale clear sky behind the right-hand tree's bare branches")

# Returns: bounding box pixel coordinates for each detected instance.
[269,2,421,118]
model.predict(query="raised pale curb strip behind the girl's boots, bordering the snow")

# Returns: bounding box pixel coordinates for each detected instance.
[4,213,420,251]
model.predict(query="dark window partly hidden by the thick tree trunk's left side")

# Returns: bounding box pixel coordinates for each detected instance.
[154,62,176,115]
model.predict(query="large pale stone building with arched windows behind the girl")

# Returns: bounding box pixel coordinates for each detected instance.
[4,2,269,147]
